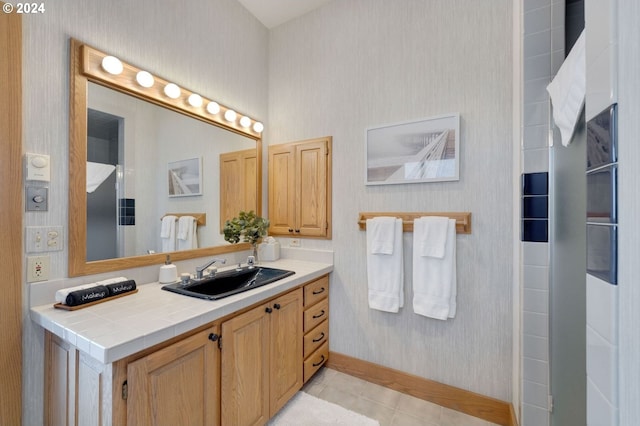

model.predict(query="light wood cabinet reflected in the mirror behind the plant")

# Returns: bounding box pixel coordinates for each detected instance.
[220,149,258,229]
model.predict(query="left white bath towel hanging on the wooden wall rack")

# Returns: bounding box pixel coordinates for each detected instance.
[367,218,404,312]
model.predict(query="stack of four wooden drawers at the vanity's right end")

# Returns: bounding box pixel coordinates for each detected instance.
[303,275,329,383]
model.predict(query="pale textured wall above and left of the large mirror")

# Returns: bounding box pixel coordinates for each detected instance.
[23,0,268,425]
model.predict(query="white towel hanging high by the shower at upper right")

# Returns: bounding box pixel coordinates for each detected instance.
[547,30,586,146]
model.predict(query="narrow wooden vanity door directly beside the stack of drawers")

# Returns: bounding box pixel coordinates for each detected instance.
[269,289,303,416]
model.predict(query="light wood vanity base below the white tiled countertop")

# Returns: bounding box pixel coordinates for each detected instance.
[45,275,329,426]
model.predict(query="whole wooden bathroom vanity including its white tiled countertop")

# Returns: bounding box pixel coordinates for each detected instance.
[31,259,333,426]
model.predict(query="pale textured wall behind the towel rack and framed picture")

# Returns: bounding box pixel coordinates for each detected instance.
[267,0,518,401]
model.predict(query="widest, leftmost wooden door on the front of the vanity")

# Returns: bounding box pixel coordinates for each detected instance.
[127,326,220,426]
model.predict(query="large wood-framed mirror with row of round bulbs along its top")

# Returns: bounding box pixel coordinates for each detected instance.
[69,39,262,276]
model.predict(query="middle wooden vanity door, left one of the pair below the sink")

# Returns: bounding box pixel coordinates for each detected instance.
[221,305,272,426]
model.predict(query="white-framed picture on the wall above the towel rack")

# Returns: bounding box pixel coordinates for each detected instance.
[365,114,460,185]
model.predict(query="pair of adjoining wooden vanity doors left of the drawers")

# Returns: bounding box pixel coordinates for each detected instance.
[220,289,302,426]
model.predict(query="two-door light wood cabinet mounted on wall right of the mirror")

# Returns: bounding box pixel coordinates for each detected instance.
[269,136,332,239]
